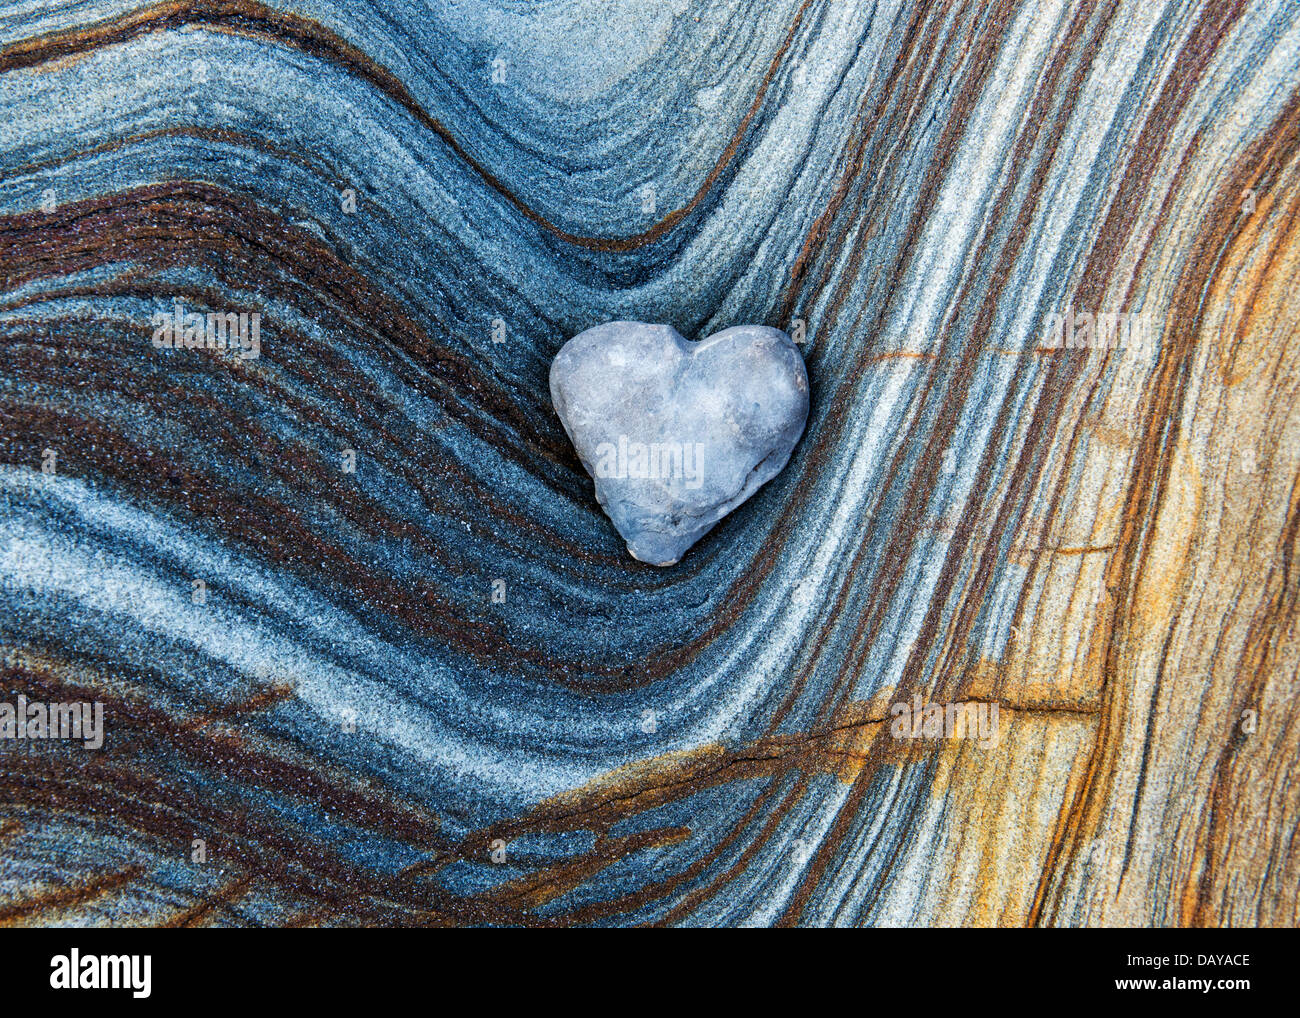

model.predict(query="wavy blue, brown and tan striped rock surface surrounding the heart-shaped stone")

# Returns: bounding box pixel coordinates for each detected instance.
[0,0,1300,926]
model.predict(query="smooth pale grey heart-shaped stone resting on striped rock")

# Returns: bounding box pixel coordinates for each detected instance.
[551,321,809,566]
